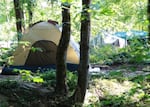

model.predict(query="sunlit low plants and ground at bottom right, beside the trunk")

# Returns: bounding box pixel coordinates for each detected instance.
[85,71,150,107]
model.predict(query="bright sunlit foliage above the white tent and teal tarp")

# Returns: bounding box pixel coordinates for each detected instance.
[91,0,148,35]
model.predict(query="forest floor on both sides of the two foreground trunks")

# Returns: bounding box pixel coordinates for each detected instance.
[0,64,150,107]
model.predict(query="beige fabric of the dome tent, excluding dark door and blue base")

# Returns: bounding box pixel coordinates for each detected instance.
[14,22,79,65]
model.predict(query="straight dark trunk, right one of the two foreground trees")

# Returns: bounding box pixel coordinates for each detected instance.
[73,0,91,106]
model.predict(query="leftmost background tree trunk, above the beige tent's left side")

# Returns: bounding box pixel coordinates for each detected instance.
[14,0,24,40]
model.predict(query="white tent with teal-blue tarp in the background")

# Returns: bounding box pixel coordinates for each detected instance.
[90,30,148,48]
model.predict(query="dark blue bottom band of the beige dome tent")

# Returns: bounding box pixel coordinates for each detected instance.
[1,63,78,75]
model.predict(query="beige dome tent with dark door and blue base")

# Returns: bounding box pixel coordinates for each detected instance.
[2,21,79,74]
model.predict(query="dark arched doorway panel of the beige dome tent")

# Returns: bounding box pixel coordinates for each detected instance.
[25,40,57,66]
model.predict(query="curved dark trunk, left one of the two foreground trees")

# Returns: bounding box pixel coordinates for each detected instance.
[56,3,71,94]
